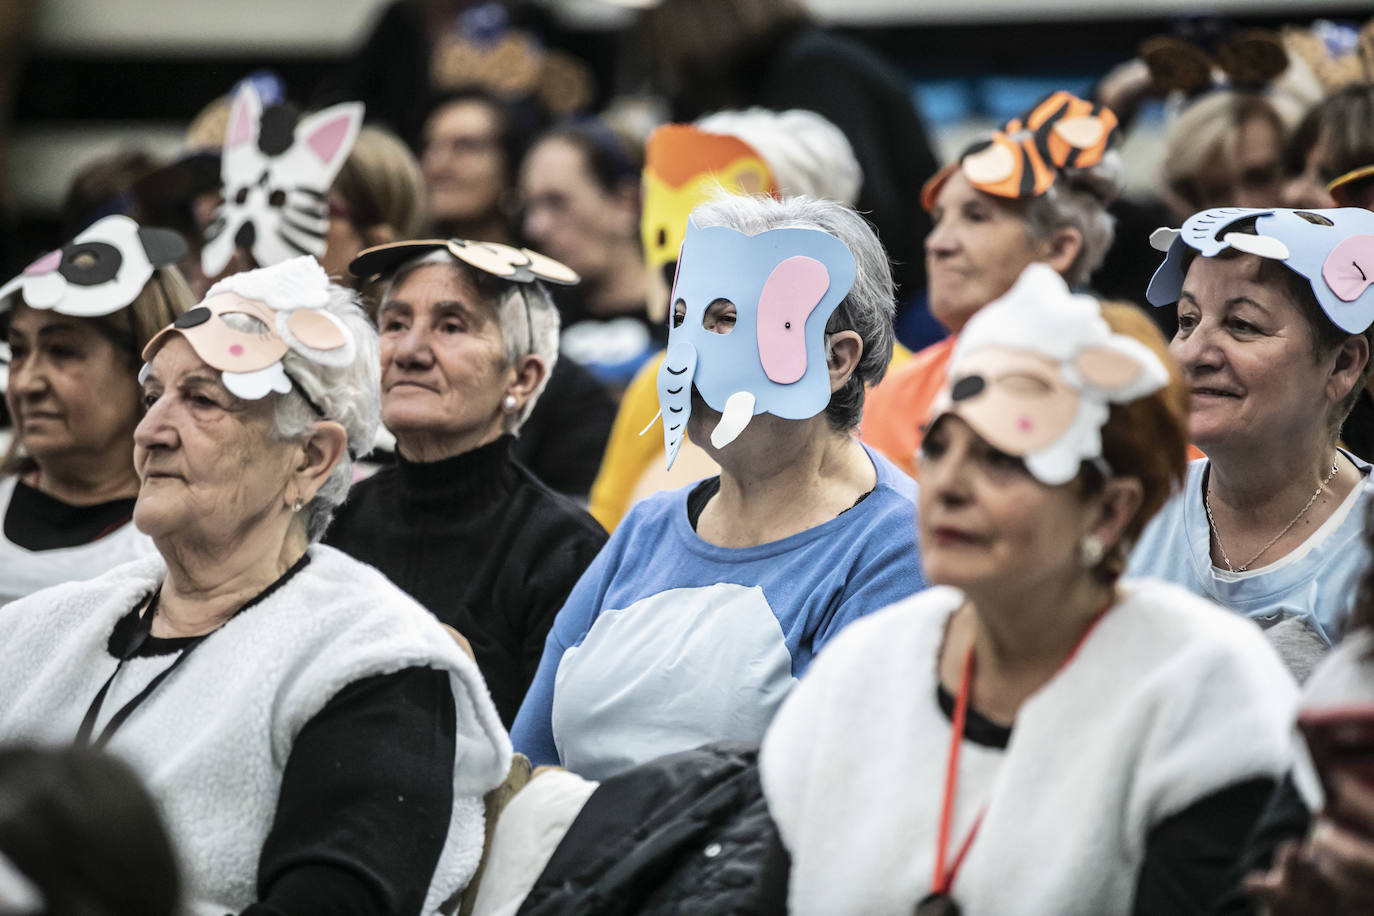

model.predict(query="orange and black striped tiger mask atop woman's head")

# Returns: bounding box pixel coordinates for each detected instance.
[921,89,1120,210]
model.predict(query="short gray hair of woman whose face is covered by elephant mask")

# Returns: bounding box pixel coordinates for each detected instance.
[691,194,896,433]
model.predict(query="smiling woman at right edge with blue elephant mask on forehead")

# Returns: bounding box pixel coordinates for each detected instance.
[1131,209,1374,676]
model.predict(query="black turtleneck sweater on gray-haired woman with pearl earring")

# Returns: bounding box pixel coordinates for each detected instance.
[324,435,606,728]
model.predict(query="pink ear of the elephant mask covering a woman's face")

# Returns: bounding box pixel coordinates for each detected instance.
[758,255,830,385]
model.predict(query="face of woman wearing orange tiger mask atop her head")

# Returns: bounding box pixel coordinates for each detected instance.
[926,170,1037,332]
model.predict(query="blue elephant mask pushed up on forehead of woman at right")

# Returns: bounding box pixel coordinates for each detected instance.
[1146,207,1374,334]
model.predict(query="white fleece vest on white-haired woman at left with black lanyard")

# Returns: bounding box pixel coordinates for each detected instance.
[0,545,511,916]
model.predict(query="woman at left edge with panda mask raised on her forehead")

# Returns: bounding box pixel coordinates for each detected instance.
[0,216,192,604]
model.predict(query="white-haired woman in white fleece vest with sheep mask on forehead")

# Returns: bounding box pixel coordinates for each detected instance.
[0,257,510,916]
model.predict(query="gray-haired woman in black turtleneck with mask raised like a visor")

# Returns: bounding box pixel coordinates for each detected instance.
[326,240,606,725]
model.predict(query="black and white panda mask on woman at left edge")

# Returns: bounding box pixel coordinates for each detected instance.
[0,214,187,319]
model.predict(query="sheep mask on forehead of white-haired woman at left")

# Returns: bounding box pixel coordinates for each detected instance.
[140,257,357,406]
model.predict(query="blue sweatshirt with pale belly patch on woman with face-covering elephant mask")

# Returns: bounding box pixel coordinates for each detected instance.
[511,446,925,779]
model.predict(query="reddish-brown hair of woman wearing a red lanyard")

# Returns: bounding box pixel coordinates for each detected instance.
[1081,302,1189,581]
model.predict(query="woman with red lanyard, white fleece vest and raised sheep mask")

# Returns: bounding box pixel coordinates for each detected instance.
[758,265,1297,916]
